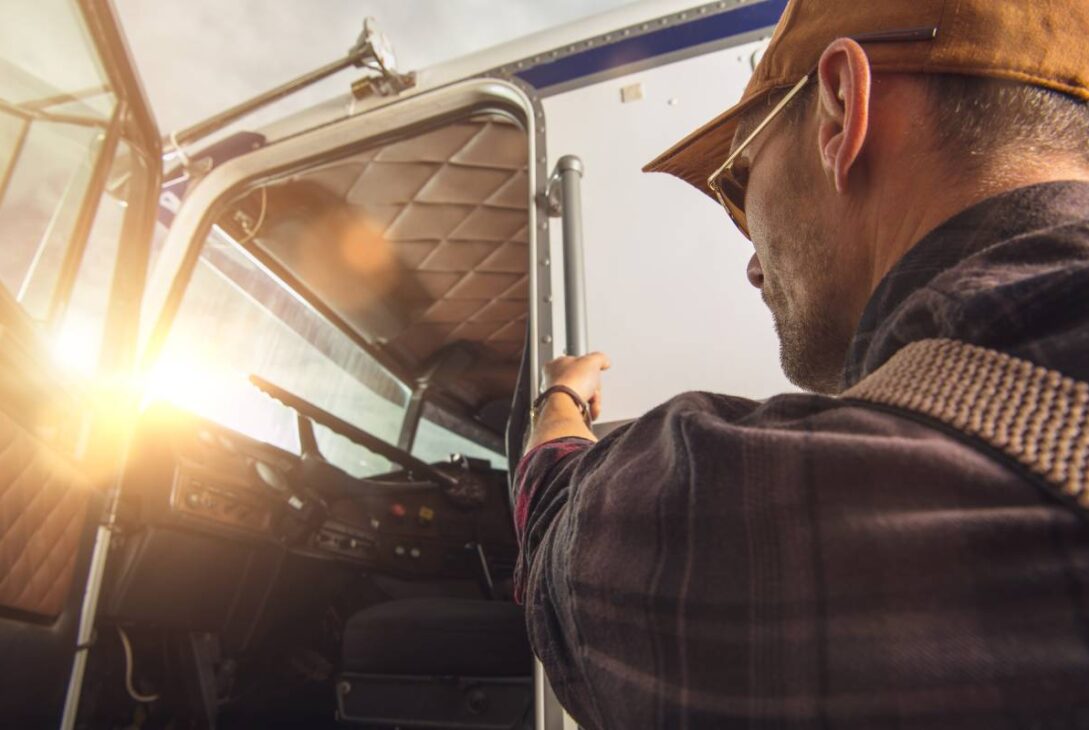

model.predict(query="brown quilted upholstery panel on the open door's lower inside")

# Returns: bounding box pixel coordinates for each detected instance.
[0,412,89,616]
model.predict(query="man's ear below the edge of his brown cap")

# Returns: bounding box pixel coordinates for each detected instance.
[817,38,871,193]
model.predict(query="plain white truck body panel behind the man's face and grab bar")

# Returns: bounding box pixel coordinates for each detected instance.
[543,40,793,422]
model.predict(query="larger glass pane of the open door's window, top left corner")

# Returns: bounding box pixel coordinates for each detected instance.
[0,0,117,319]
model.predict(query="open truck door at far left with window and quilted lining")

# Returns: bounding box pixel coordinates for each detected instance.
[0,0,161,728]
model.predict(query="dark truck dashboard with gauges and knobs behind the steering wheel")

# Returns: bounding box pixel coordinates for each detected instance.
[107,405,517,644]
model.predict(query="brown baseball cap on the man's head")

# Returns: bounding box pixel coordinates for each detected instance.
[644,0,1089,198]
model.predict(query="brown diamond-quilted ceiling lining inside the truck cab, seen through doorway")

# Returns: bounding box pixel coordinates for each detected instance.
[257,115,529,405]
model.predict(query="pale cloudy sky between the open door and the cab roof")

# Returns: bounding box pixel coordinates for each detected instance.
[114,0,631,134]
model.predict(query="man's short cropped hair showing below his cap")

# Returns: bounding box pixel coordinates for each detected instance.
[744,74,1089,169]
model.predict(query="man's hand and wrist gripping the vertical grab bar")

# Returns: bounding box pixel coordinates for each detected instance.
[526,352,611,453]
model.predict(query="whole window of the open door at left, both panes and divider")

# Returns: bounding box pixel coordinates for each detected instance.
[0,0,158,373]
